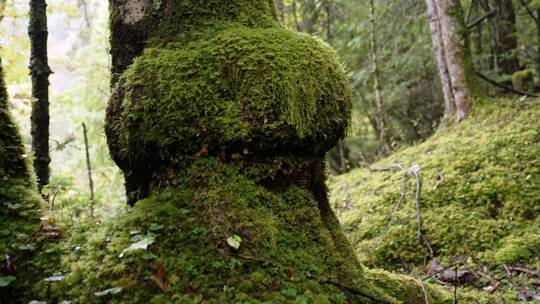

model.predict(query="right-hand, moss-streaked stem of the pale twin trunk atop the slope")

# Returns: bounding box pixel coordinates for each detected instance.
[435,0,475,121]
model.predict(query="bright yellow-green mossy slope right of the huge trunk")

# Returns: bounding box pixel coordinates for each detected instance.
[330,99,540,269]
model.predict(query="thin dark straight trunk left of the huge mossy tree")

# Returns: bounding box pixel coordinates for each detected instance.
[28,0,51,190]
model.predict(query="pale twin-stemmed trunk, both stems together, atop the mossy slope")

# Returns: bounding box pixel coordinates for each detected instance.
[426,0,475,121]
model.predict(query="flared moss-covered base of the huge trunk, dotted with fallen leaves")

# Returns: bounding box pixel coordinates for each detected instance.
[29,159,468,304]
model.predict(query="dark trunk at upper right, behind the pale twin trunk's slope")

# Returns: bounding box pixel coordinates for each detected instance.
[489,0,519,75]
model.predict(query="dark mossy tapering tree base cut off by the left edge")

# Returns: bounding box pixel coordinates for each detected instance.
[0,58,54,303]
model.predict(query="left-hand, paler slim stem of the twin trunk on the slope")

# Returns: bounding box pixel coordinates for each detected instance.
[426,0,456,126]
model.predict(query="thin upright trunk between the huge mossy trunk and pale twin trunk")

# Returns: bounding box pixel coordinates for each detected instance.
[369,0,390,155]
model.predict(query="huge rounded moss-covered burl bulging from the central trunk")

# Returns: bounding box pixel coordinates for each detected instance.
[107,24,351,202]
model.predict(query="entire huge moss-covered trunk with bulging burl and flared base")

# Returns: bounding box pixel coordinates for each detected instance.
[78,0,462,303]
